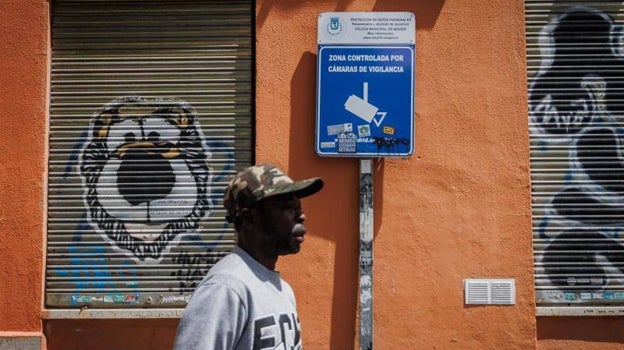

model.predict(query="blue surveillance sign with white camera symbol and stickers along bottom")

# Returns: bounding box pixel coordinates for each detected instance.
[316,45,414,157]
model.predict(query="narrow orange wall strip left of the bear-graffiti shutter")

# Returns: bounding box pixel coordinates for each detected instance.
[0,0,49,332]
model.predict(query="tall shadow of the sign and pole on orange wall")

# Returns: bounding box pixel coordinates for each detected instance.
[288,52,368,349]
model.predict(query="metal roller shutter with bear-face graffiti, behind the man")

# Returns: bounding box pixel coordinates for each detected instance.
[45,0,254,309]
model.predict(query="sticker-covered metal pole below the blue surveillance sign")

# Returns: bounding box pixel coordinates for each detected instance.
[359,158,373,350]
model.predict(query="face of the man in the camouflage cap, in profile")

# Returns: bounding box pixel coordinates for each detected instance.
[258,195,306,256]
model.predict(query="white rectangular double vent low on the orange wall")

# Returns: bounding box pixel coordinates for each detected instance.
[464,279,516,305]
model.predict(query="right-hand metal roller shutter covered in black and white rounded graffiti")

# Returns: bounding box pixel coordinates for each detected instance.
[525,0,624,315]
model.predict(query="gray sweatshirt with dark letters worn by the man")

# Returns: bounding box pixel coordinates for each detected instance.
[174,247,302,350]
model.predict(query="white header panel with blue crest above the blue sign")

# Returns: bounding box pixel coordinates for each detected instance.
[318,12,416,45]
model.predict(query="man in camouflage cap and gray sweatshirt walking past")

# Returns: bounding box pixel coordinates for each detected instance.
[175,164,323,350]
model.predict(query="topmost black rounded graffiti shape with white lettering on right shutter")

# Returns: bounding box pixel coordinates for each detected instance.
[529,6,624,135]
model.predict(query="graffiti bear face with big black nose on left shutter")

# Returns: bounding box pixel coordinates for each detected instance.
[80,97,210,260]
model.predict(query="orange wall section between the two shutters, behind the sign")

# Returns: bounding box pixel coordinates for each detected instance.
[256,0,536,349]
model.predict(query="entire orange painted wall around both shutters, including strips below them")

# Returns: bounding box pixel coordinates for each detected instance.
[0,0,624,349]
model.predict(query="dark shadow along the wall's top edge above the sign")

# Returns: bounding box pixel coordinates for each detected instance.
[256,0,444,30]
